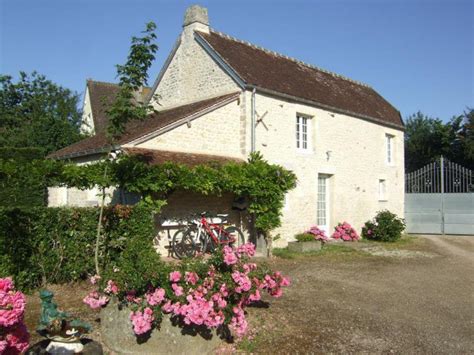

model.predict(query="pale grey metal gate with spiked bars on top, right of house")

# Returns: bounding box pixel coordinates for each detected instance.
[405,157,474,235]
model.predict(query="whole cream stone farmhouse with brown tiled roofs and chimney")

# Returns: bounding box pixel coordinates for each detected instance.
[49,5,404,250]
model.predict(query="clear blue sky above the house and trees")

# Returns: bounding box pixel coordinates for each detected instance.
[0,0,474,120]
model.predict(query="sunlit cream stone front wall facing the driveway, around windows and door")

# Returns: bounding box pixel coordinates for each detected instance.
[246,92,404,245]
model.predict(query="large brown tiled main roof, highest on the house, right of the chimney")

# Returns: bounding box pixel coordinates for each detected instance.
[196,31,403,128]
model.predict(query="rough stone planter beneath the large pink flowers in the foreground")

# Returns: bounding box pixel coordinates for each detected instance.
[100,300,225,354]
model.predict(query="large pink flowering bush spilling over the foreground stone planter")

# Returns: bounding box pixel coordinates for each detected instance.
[84,243,290,338]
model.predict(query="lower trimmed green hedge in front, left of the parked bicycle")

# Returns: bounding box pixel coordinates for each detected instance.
[0,205,154,289]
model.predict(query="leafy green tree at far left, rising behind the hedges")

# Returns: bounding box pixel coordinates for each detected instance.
[0,72,82,154]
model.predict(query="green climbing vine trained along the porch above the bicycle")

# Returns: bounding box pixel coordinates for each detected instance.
[49,153,296,232]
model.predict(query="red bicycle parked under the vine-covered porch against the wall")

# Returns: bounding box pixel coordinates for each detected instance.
[173,212,245,258]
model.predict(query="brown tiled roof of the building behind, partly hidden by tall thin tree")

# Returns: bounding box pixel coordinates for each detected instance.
[87,79,151,133]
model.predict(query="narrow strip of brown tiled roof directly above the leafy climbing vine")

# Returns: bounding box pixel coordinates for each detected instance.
[123,148,244,166]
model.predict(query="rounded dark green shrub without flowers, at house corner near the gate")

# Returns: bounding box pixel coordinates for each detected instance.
[362,210,405,242]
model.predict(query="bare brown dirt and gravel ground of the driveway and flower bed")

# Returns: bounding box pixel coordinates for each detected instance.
[26,236,474,354]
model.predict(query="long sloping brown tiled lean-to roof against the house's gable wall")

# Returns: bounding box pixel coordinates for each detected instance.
[48,93,239,159]
